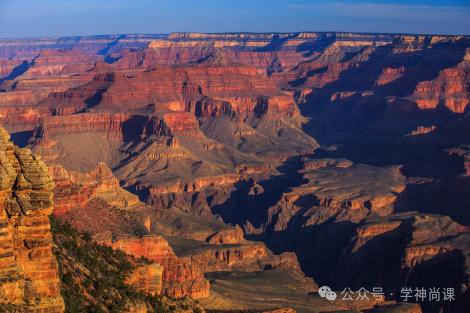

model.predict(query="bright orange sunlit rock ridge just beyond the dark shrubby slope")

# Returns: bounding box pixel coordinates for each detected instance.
[46,164,209,298]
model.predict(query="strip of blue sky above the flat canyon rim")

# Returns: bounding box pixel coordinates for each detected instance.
[0,0,470,38]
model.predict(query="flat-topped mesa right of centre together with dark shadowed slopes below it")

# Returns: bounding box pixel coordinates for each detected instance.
[211,158,405,288]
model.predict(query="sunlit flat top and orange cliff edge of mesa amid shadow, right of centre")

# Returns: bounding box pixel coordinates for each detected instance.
[258,159,405,236]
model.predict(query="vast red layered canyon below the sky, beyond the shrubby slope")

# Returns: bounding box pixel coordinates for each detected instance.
[0,32,470,313]
